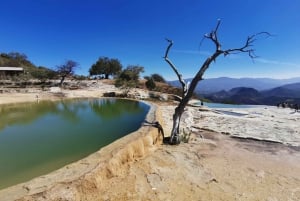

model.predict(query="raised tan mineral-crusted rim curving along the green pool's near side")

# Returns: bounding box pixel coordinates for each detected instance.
[0,101,163,201]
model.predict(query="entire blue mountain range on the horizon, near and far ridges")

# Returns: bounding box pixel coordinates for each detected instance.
[169,77,300,105]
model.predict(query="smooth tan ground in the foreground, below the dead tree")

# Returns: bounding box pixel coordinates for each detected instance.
[96,131,300,201]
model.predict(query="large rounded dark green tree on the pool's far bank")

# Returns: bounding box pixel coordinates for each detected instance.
[89,57,122,79]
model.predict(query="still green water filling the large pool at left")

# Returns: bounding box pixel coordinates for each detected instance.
[0,99,149,189]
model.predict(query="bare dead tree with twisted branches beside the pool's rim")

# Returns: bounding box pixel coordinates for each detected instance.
[164,20,270,144]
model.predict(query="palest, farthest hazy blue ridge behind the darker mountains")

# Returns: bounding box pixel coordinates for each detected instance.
[169,77,300,94]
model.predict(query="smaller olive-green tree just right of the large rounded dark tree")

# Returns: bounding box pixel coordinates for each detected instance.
[115,65,144,94]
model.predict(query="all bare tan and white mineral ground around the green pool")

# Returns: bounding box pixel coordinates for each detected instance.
[0,82,300,201]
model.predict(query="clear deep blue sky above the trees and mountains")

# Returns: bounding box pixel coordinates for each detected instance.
[0,0,300,80]
